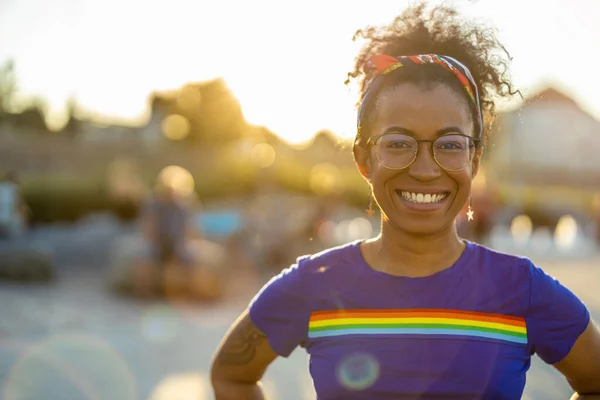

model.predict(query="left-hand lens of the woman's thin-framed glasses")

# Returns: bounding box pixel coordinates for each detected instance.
[375,133,419,169]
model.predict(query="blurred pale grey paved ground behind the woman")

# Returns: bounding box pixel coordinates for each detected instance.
[0,217,600,400]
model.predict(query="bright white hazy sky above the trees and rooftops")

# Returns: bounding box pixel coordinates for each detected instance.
[0,0,600,143]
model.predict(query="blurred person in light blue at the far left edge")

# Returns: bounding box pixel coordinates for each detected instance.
[0,171,29,239]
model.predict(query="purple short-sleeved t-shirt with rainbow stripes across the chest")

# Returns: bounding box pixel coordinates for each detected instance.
[250,241,590,400]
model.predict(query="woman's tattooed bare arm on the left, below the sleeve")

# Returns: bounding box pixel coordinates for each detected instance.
[211,310,277,400]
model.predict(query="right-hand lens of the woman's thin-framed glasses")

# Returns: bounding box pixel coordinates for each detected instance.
[433,135,475,171]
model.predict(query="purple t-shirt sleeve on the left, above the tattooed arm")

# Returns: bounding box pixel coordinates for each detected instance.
[250,261,310,357]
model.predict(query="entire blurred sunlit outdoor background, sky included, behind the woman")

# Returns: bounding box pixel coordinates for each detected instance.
[0,0,600,400]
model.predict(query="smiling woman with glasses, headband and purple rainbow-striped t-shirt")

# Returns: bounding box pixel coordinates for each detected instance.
[212,5,600,400]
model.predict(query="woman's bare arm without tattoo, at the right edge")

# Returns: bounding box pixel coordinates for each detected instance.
[554,321,600,400]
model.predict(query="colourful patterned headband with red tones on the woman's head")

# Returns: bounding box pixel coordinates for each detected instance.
[357,54,483,135]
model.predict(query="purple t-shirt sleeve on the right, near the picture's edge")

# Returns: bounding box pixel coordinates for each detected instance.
[527,263,590,364]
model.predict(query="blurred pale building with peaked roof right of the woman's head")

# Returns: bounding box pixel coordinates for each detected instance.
[492,88,600,187]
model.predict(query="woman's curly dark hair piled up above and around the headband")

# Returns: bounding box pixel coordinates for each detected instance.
[346,2,520,144]
